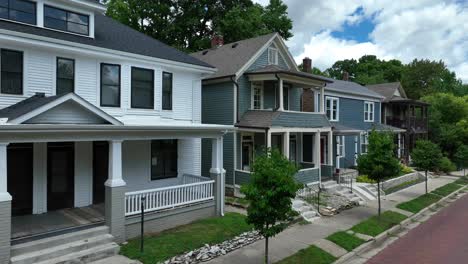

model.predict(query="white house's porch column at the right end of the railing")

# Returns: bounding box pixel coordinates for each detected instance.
[210,137,226,216]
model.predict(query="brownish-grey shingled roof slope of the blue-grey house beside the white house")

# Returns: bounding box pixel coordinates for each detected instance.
[191,33,296,79]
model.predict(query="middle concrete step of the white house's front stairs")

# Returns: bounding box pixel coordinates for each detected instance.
[10,234,114,264]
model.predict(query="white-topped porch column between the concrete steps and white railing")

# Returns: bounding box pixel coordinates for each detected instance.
[104,140,126,243]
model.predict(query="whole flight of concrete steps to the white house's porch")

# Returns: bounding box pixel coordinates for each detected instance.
[10,226,119,264]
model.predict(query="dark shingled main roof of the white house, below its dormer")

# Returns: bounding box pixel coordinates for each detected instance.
[0,13,213,68]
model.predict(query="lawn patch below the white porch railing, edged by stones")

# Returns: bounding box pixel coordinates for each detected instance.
[120,213,252,263]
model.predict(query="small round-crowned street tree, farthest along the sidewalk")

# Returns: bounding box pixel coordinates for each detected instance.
[411,140,442,193]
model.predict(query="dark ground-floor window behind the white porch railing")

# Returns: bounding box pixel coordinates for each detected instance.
[151,139,177,181]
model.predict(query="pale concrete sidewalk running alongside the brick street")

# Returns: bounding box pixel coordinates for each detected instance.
[207,176,455,264]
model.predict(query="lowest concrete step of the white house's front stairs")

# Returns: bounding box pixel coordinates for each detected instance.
[36,242,120,264]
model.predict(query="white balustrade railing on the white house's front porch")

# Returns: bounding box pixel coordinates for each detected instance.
[125,176,214,216]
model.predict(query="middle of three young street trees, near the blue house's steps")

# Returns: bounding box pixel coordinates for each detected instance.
[357,131,400,216]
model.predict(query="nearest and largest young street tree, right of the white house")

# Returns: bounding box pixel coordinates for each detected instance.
[241,150,301,263]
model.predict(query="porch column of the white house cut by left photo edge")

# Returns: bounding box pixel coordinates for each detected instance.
[0,142,11,263]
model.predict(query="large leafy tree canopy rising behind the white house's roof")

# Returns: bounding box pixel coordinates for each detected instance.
[106,0,292,52]
